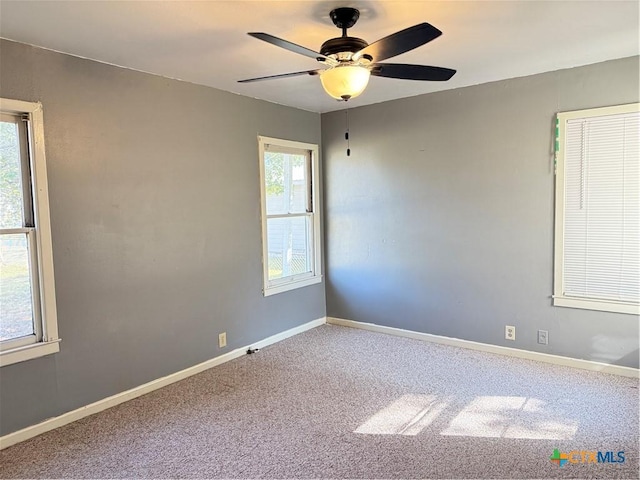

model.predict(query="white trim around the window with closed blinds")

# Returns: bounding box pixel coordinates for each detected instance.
[553,103,640,315]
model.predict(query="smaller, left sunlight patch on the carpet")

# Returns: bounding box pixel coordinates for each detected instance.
[355,395,447,435]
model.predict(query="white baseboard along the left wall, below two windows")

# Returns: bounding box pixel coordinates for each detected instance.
[0,317,326,450]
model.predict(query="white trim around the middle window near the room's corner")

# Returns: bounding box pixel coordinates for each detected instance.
[258,136,322,297]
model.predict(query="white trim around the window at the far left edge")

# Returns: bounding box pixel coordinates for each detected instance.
[0,98,60,367]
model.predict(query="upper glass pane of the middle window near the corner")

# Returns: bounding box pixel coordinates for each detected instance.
[264,152,308,215]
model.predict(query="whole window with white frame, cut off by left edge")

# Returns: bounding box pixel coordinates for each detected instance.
[0,99,60,366]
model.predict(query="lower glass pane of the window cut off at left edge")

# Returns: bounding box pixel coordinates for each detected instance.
[0,234,34,341]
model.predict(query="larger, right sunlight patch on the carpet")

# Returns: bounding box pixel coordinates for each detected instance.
[442,396,578,440]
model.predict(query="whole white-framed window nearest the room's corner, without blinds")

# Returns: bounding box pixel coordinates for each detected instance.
[258,137,322,296]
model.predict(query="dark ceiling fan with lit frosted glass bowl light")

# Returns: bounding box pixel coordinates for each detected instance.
[239,7,456,101]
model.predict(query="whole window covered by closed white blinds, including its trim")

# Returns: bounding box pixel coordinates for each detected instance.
[553,104,640,314]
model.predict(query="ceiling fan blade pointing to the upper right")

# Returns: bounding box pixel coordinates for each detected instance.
[354,22,442,62]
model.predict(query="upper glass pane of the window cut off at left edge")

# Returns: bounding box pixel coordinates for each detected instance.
[0,122,24,228]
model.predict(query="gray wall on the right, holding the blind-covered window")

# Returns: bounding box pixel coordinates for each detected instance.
[322,57,639,367]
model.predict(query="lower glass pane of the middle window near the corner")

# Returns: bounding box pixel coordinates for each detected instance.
[267,216,311,280]
